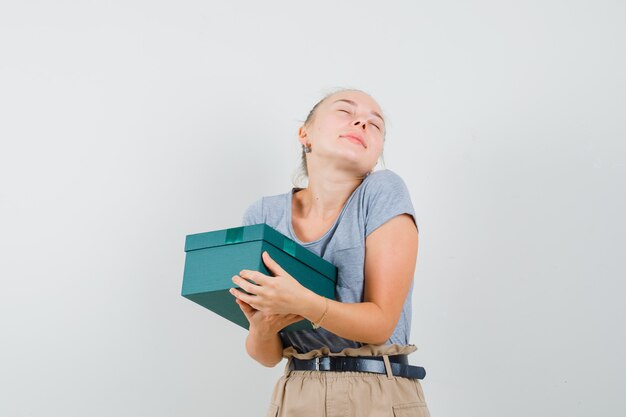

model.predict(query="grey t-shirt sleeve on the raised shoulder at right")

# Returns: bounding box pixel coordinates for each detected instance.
[364,170,419,237]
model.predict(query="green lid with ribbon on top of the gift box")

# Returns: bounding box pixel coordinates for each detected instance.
[185,223,337,281]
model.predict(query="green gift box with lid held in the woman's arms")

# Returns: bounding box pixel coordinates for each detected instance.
[182,223,337,331]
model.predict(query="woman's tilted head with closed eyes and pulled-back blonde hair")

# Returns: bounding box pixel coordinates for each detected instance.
[298,91,385,175]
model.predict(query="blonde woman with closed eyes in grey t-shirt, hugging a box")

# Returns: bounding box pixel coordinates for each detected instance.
[231,90,430,417]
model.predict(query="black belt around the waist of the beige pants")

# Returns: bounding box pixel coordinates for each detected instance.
[289,355,426,379]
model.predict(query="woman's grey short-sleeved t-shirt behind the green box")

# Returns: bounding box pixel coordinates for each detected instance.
[243,169,417,353]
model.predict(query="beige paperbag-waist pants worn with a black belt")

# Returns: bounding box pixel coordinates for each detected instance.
[267,344,430,417]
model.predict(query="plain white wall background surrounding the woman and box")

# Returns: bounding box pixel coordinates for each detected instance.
[0,0,626,417]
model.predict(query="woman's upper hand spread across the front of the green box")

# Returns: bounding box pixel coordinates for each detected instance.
[230,252,311,314]
